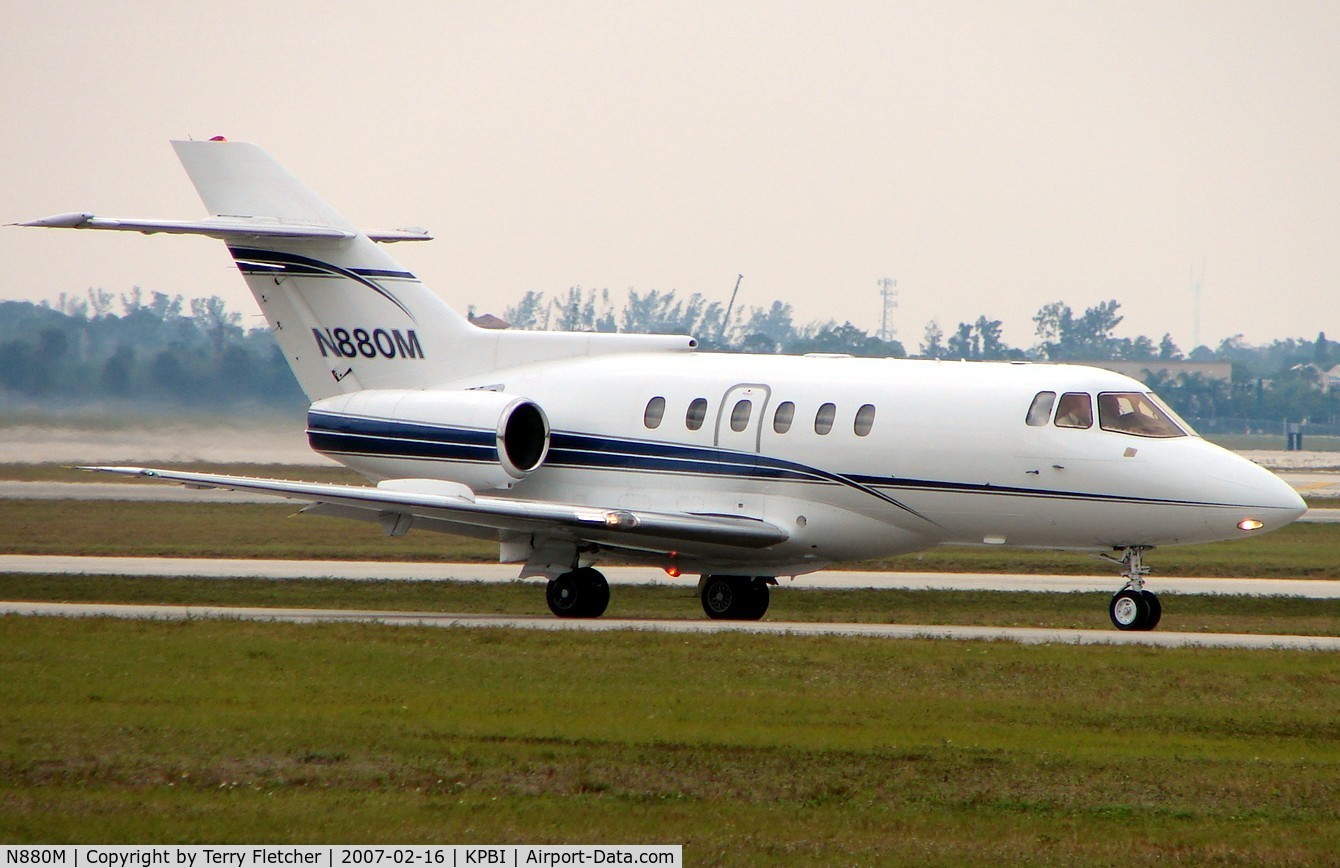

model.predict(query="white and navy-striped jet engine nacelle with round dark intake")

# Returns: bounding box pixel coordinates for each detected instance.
[307,390,549,490]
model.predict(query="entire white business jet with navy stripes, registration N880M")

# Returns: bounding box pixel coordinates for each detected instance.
[21,139,1305,630]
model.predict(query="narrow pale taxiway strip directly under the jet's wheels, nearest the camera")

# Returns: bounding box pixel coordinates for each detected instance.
[0,603,1340,651]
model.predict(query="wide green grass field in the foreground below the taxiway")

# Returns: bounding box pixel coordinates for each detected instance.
[0,618,1340,864]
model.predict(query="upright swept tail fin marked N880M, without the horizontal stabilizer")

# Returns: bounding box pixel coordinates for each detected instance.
[173,141,482,401]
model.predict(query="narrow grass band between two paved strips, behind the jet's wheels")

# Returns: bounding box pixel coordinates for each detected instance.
[0,575,1340,636]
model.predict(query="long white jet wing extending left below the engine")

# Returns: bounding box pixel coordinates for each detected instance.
[80,467,787,551]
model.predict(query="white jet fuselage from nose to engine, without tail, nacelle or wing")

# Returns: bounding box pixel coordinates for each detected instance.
[318,354,1304,575]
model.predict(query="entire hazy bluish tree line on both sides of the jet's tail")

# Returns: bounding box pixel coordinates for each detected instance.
[0,287,1340,430]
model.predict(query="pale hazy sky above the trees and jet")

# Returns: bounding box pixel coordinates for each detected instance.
[0,0,1340,350]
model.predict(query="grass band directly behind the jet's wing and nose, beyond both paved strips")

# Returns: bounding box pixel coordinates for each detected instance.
[0,500,1340,579]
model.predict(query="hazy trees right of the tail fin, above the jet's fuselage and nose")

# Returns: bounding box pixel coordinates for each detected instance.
[504,287,1340,434]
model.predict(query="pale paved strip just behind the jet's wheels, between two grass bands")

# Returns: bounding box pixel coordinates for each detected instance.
[0,555,1340,599]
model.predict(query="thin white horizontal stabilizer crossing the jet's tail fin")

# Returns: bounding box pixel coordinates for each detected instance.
[13,212,433,242]
